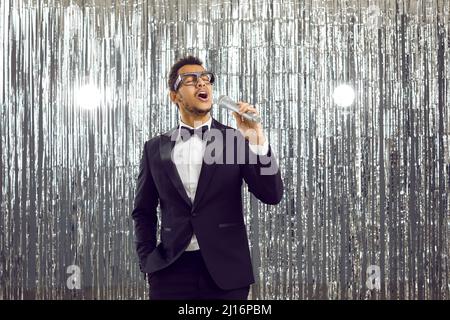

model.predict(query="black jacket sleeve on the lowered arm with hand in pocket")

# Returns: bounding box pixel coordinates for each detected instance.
[131,140,159,271]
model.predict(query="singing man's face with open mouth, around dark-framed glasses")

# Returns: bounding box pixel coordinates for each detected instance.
[170,64,212,115]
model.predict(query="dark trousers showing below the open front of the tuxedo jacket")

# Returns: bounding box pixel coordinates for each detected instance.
[148,250,250,300]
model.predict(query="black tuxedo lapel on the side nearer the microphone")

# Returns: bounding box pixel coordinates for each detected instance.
[192,119,225,210]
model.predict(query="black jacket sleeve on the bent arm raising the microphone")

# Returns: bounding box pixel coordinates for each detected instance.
[241,140,283,205]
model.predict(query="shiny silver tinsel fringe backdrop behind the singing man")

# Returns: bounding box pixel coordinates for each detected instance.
[0,0,450,299]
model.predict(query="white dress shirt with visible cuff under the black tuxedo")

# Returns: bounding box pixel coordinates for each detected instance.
[173,117,269,251]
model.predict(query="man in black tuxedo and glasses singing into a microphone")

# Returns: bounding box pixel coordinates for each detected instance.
[132,56,283,300]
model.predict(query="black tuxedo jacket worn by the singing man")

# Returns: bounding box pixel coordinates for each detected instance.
[132,119,283,289]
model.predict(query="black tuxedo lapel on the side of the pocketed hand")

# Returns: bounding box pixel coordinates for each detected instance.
[159,128,192,206]
